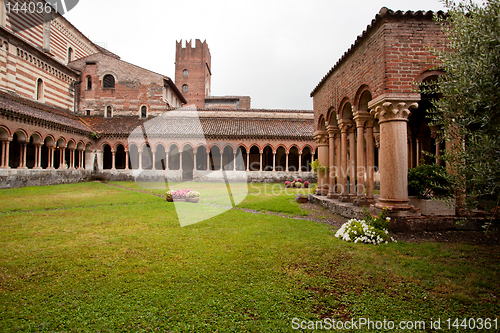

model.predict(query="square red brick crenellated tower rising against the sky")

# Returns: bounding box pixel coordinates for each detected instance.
[175,39,212,108]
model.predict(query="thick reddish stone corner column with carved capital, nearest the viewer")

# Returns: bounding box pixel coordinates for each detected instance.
[368,94,420,216]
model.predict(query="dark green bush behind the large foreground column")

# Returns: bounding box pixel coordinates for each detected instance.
[408,164,453,199]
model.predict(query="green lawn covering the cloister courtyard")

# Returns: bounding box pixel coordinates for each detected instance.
[0,183,500,332]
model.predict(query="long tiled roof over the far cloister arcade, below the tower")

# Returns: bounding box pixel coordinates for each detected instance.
[81,116,313,139]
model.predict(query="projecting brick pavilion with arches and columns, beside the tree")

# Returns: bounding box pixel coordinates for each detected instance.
[311,8,446,215]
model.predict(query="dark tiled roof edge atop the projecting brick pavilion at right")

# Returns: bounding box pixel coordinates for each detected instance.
[310,7,445,97]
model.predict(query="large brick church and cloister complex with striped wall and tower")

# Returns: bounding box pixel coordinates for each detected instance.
[0,0,316,187]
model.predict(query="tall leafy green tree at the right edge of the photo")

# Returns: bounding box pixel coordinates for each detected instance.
[423,0,500,214]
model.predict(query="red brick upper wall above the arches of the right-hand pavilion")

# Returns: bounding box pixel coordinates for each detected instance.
[312,14,446,129]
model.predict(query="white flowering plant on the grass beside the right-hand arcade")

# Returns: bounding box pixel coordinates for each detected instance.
[335,208,395,245]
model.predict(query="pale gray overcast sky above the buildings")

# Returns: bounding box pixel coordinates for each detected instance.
[65,0,444,109]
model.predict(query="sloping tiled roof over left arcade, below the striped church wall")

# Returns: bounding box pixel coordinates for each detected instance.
[0,91,92,133]
